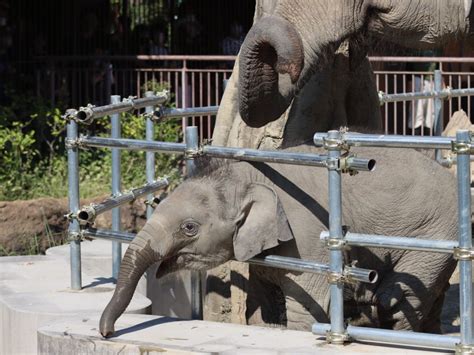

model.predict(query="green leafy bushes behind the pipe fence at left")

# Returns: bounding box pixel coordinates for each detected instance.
[0,82,182,200]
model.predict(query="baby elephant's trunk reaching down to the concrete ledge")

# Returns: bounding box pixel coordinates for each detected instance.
[99,222,172,337]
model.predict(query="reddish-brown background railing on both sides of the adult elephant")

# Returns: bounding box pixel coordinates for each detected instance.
[33,56,474,138]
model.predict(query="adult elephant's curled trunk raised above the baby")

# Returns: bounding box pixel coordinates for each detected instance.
[239,16,304,127]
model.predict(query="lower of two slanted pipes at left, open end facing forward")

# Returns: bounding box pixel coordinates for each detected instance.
[77,178,169,224]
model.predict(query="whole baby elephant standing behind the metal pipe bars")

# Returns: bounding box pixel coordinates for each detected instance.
[100,146,457,337]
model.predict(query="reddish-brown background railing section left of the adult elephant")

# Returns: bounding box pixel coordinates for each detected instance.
[35,55,235,138]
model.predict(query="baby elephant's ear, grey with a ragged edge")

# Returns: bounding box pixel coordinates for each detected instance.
[234,183,293,261]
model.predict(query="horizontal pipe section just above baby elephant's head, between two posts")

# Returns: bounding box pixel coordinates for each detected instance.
[202,145,328,167]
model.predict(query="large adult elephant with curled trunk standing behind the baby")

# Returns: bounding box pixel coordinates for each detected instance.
[214,0,474,147]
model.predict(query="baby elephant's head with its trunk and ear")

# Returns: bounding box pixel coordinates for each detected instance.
[100,168,293,337]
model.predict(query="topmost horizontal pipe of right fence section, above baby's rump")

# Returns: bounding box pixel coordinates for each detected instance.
[314,132,454,150]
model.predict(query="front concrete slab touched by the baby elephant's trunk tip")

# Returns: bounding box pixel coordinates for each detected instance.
[38,314,443,355]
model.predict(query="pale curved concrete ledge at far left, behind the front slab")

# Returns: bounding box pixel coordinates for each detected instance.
[0,252,151,354]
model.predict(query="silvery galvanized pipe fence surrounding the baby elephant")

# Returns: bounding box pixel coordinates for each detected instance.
[66,91,474,354]
